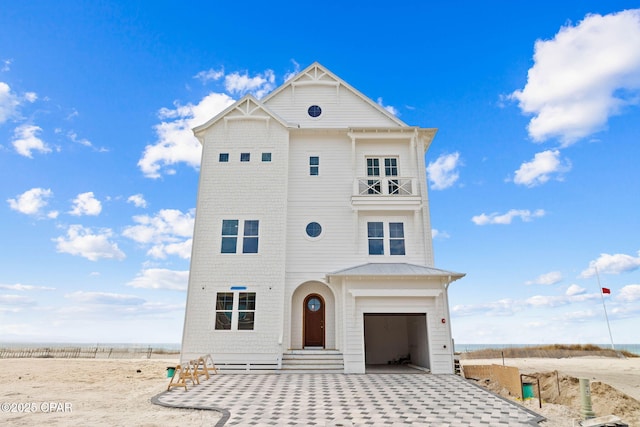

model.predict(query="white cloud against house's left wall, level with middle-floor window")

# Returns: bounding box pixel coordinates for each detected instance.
[122,209,194,259]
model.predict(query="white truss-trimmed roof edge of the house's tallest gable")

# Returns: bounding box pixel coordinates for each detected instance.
[262,62,407,127]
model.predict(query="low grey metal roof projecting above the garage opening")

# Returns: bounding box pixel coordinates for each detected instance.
[327,263,465,282]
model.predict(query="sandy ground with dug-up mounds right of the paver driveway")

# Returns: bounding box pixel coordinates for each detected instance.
[461,357,640,427]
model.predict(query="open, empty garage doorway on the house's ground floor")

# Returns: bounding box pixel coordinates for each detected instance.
[364,313,430,369]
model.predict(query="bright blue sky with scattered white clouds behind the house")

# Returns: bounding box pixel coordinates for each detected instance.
[0,0,640,343]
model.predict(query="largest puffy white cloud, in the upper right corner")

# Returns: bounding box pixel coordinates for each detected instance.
[511,9,640,146]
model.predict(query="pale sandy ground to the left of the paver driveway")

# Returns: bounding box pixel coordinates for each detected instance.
[0,359,220,427]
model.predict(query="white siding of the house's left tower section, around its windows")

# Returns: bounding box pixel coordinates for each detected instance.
[182,120,288,362]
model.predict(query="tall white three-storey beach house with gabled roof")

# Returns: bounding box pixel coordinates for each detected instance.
[181,63,464,373]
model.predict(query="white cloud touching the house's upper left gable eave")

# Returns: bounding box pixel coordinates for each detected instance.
[138,93,234,178]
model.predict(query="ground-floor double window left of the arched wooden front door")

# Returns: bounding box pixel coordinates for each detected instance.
[215,292,256,331]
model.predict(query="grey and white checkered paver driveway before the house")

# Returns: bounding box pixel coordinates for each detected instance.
[152,374,544,427]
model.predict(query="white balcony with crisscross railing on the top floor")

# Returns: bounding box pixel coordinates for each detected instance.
[351,176,421,210]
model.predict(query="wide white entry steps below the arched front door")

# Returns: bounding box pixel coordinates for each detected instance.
[280,349,344,374]
